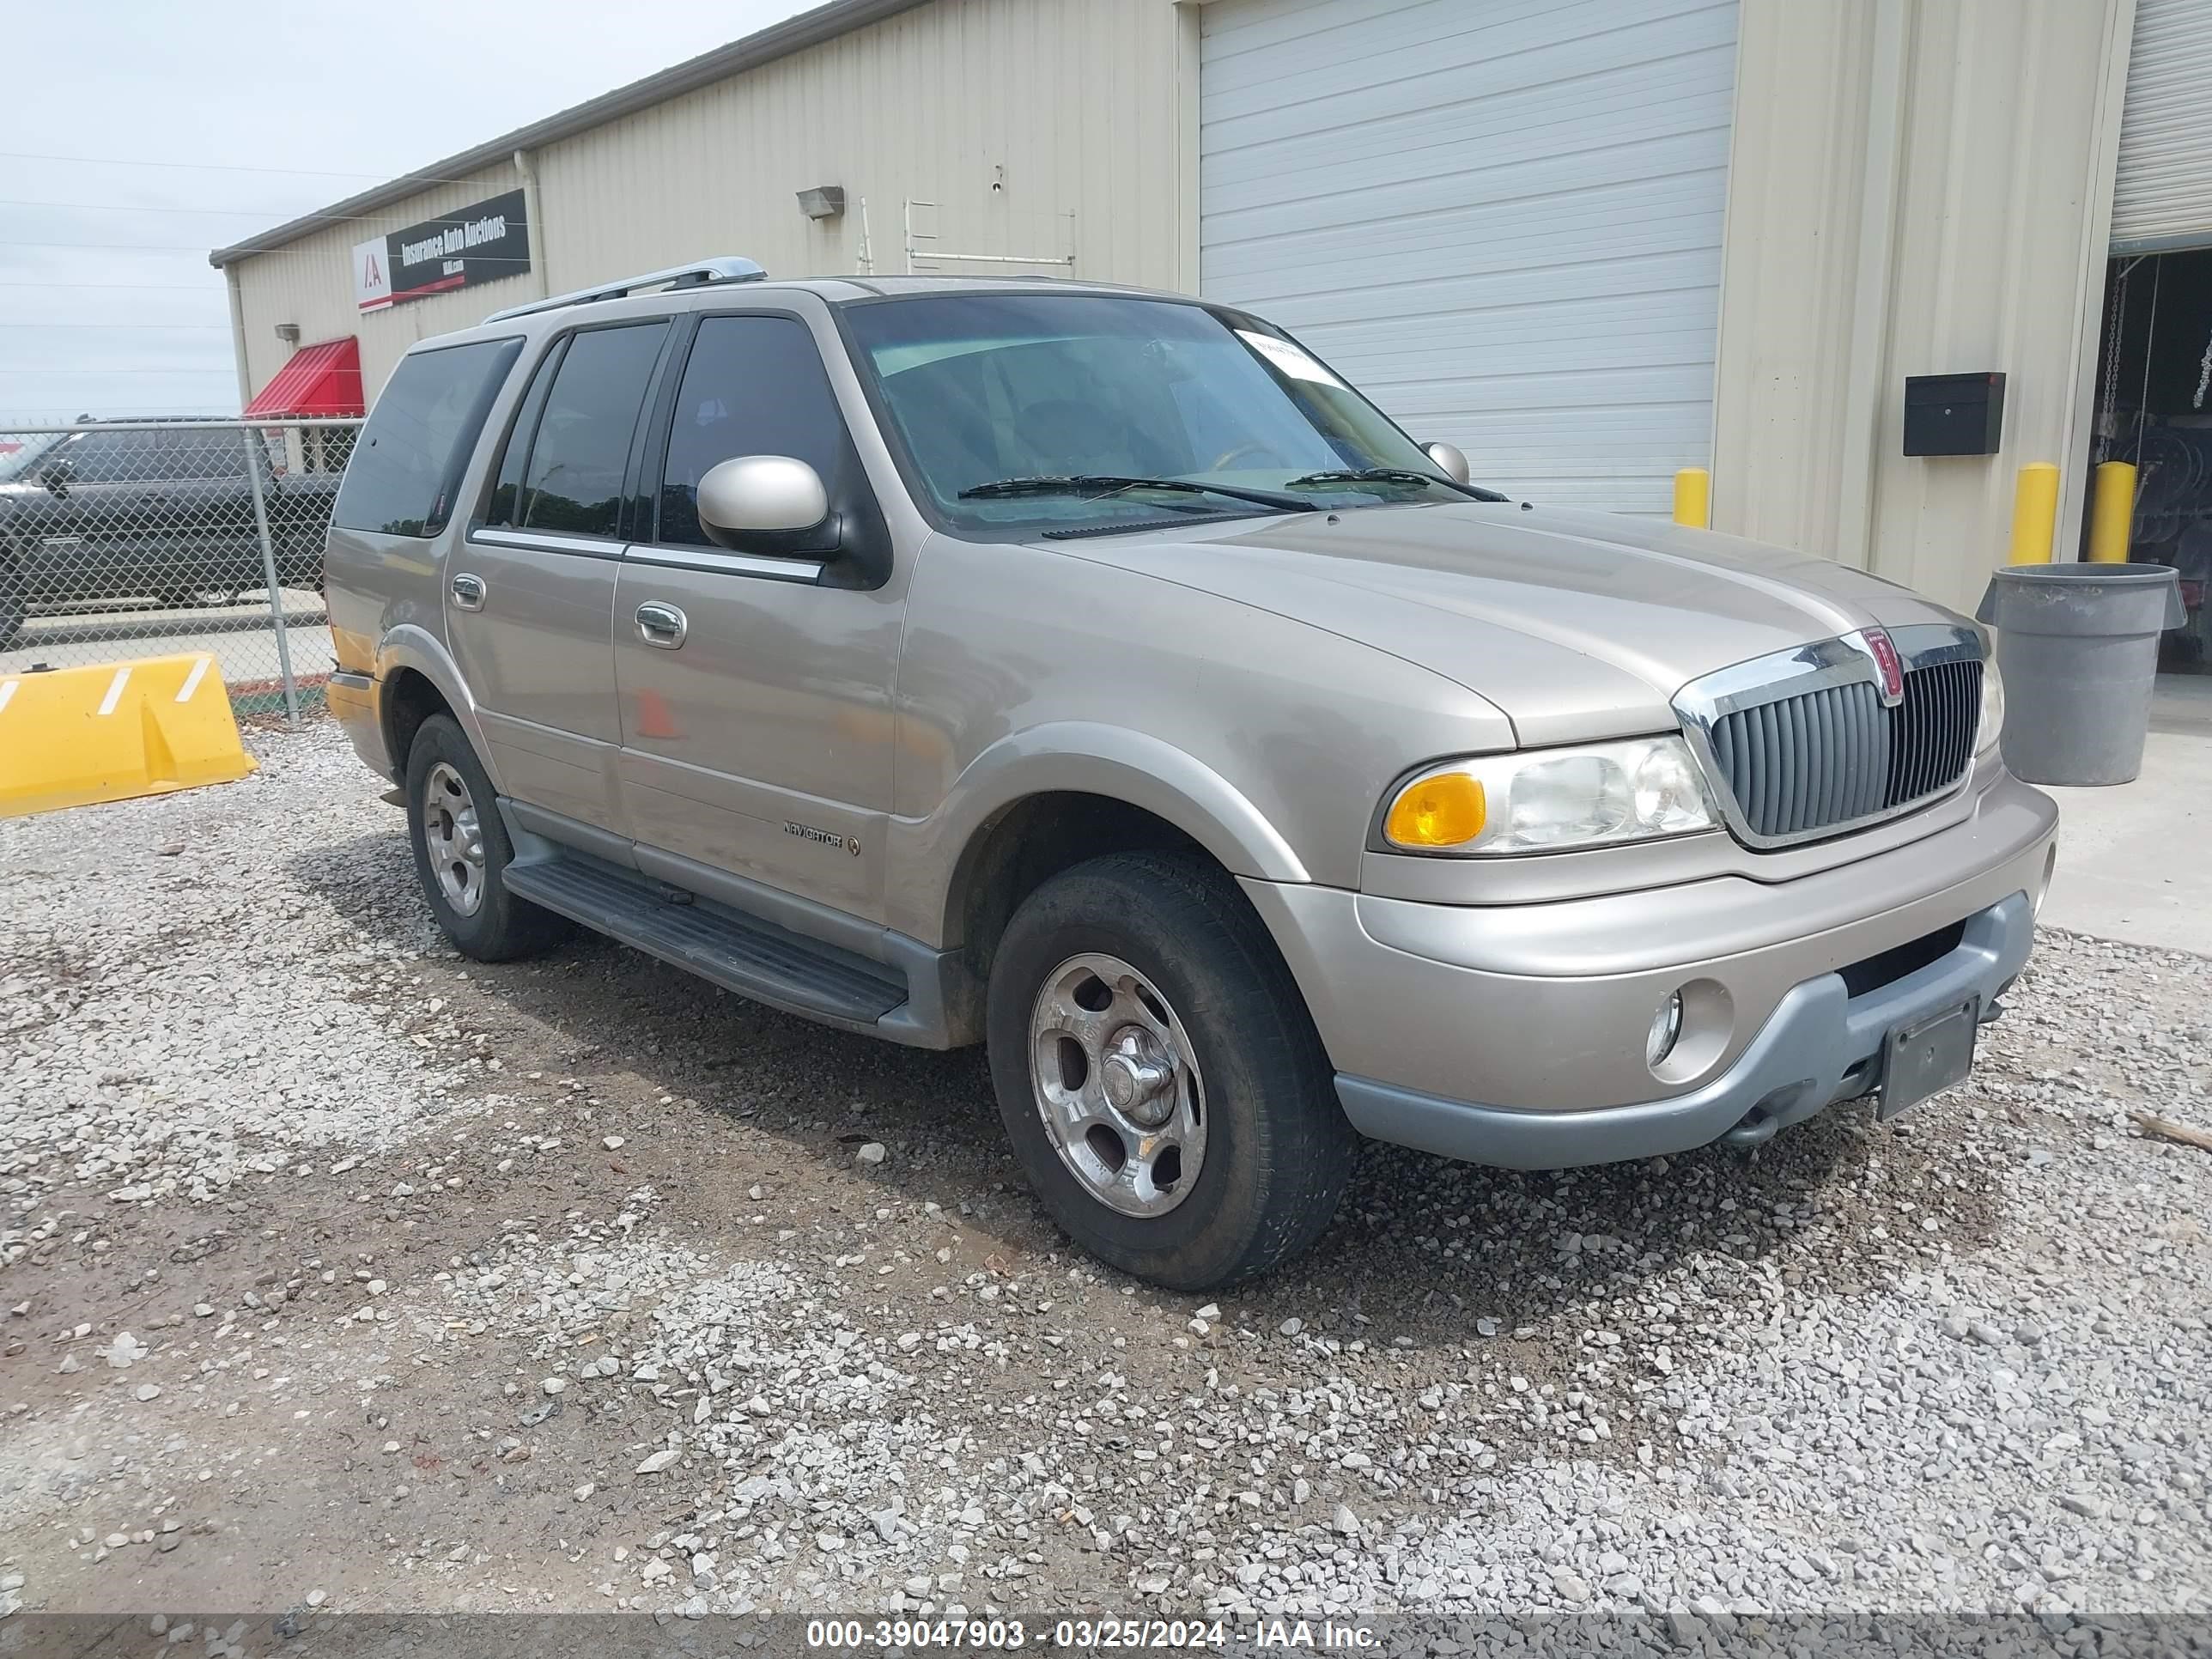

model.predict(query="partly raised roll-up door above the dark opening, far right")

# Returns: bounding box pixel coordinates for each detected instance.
[2112,0,2212,254]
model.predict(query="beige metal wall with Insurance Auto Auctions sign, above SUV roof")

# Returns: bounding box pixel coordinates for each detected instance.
[237,0,1186,406]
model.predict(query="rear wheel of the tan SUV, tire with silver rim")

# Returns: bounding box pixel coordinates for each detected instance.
[407,714,571,963]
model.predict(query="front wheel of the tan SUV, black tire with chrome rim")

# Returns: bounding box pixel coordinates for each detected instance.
[987,852,1358,1290]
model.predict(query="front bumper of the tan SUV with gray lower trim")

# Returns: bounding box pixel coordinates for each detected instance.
[1243,776,2057,1168]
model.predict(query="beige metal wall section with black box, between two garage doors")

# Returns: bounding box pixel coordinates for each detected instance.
[1712,0,2135,611]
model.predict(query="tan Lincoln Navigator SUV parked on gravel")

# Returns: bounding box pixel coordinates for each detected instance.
[327,261,2055,1287]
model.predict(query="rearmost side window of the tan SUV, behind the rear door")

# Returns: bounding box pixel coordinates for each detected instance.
[330,341,522,535]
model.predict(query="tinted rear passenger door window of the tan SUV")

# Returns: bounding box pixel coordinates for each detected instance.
[502,323,668,546]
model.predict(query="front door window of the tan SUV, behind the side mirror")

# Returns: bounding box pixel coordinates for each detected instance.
[659,316,849,546]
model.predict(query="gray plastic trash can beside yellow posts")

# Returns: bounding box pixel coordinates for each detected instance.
[1975,564,2188,783]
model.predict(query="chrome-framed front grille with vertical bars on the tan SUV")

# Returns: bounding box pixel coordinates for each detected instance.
[1674,626,1982,848]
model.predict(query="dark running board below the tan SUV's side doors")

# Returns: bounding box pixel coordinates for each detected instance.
[504,854,907,1029]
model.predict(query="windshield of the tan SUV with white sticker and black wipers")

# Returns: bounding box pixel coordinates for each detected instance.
[845,295,1471,531]
